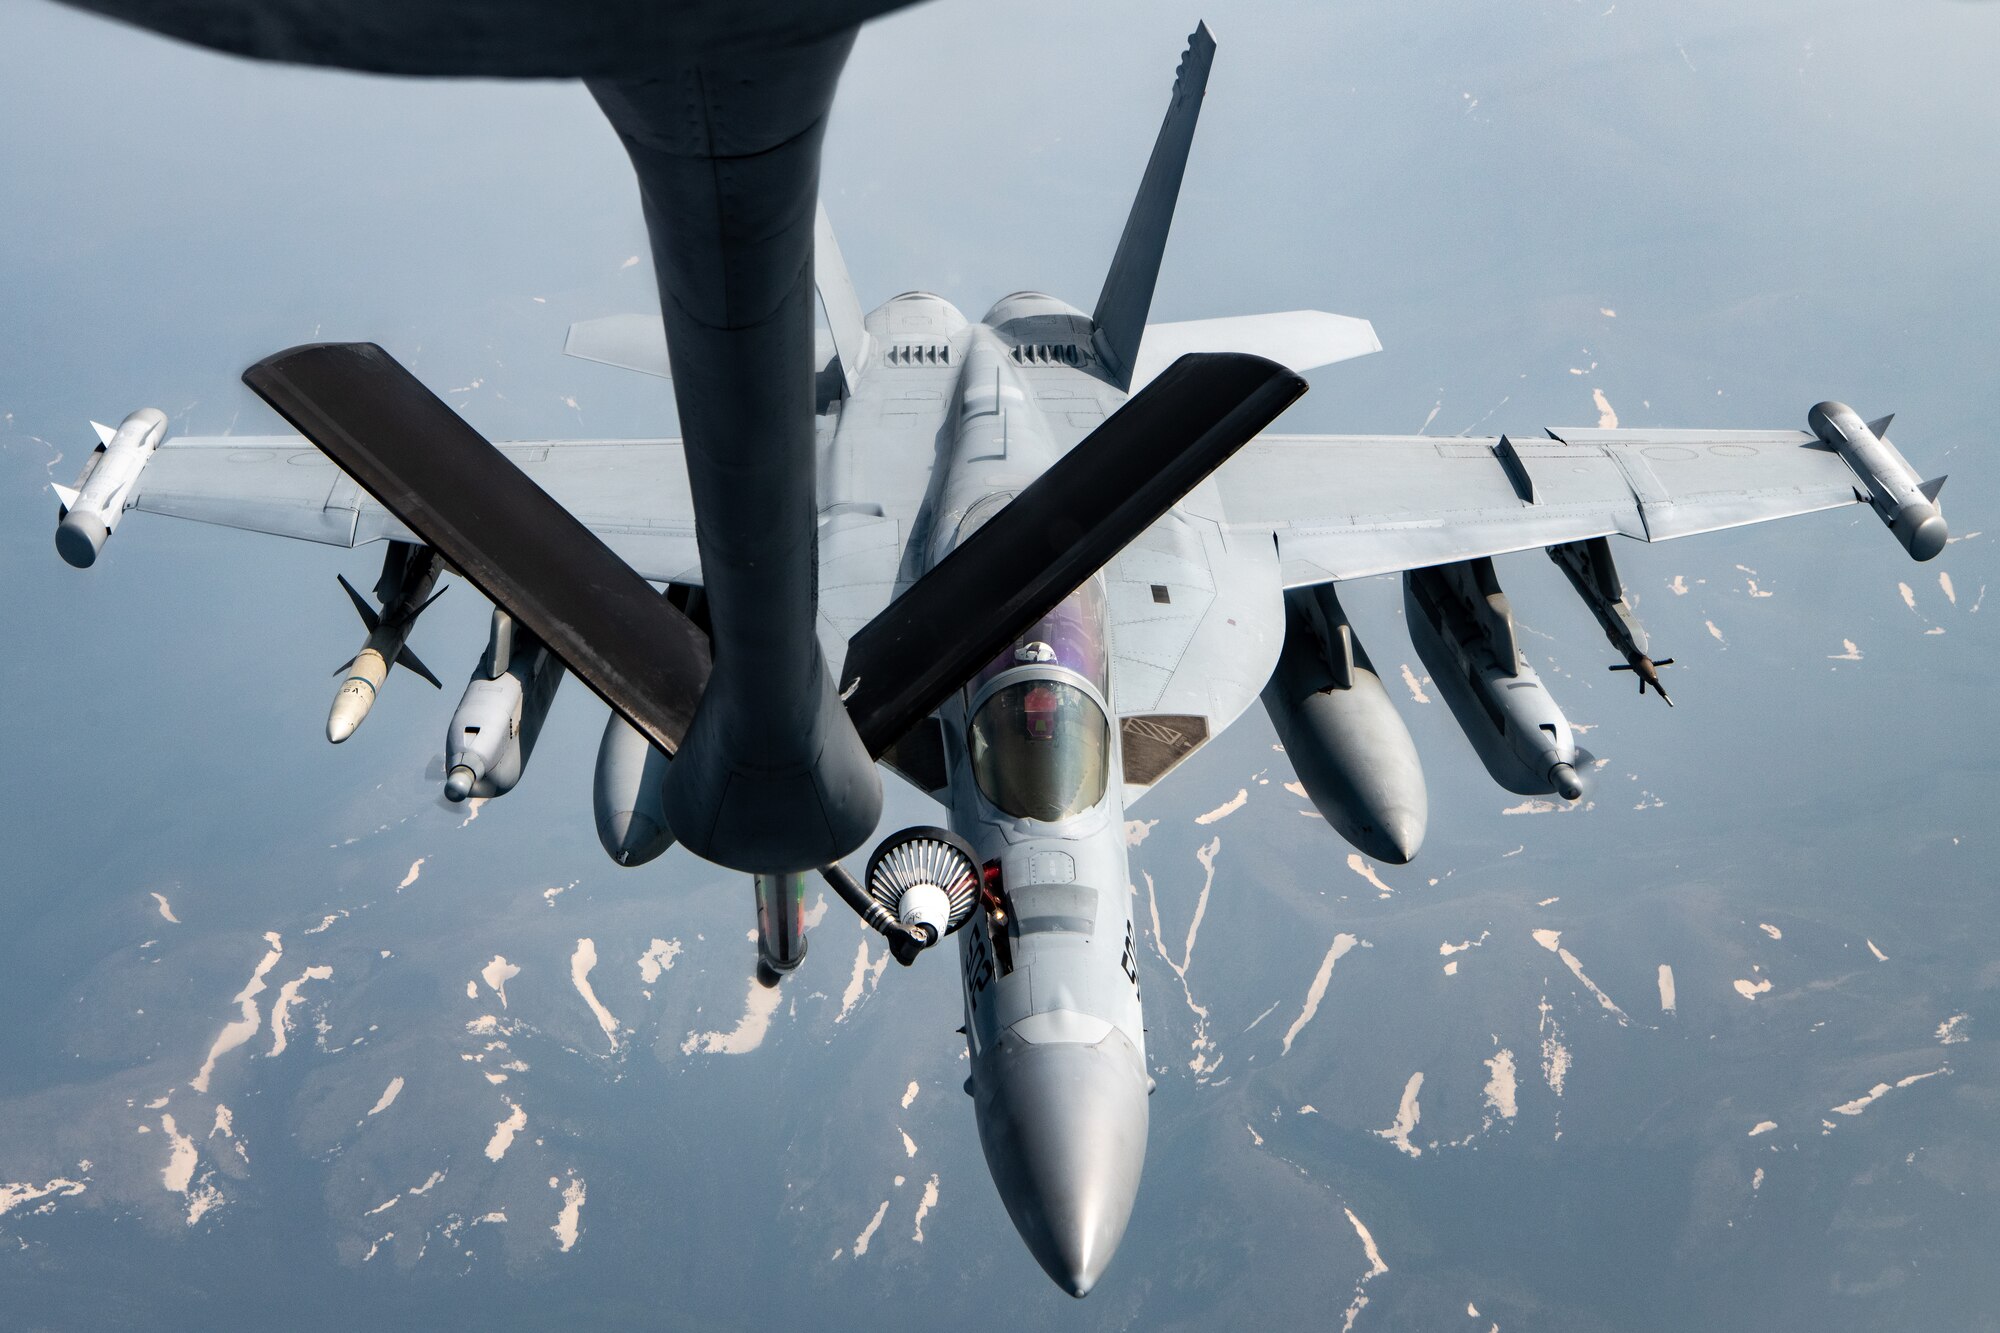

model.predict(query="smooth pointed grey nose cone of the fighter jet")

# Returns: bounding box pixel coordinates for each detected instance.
[978,1031,1146,1297]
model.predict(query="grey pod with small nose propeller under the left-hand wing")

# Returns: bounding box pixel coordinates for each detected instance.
[444,606,562,801]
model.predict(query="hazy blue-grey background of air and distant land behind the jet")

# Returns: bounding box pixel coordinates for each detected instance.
[0,0,2000,1331]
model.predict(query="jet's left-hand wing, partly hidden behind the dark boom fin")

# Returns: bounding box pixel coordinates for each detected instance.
[130,434,702,582]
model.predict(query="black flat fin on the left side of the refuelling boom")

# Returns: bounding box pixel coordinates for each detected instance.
[244,342,710,755]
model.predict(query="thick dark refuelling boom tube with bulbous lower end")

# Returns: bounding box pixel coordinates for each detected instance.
[590,28,882,873]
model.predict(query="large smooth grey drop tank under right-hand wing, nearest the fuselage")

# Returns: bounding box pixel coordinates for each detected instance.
[1264,584,1430,865]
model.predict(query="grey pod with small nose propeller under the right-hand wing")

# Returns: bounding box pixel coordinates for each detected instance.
[1402,556,1594,801]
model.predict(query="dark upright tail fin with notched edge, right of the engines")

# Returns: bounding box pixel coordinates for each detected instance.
[1090,24,1216,388]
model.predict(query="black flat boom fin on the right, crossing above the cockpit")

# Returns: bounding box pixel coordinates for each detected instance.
[840,354,1306,757]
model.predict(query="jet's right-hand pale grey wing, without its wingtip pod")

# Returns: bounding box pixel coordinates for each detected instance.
[1216,426,1866,586]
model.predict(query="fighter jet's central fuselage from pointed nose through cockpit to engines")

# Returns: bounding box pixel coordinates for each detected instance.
[822,292,1150,1295]
